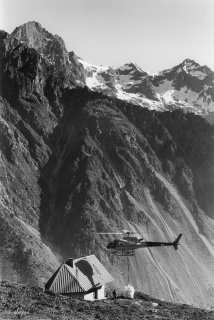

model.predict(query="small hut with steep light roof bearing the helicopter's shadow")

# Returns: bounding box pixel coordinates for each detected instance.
[45,255,114,301]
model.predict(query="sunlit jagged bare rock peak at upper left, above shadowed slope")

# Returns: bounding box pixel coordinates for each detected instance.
[5,22,85,86]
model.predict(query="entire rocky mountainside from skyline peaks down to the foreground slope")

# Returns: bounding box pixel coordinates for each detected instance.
[0,22,214,306]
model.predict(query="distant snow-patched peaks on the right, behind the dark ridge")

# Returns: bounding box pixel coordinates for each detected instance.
[79,59,214,115]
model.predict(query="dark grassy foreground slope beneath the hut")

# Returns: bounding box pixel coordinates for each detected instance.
[0,281,214,320]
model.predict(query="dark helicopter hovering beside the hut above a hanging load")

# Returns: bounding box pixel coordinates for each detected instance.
[99,230,182,256]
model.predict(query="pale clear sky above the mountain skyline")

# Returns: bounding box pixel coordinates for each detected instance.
[0,0,214,73]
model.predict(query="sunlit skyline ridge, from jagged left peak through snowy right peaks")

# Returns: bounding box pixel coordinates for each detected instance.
[2,21,214,115]
